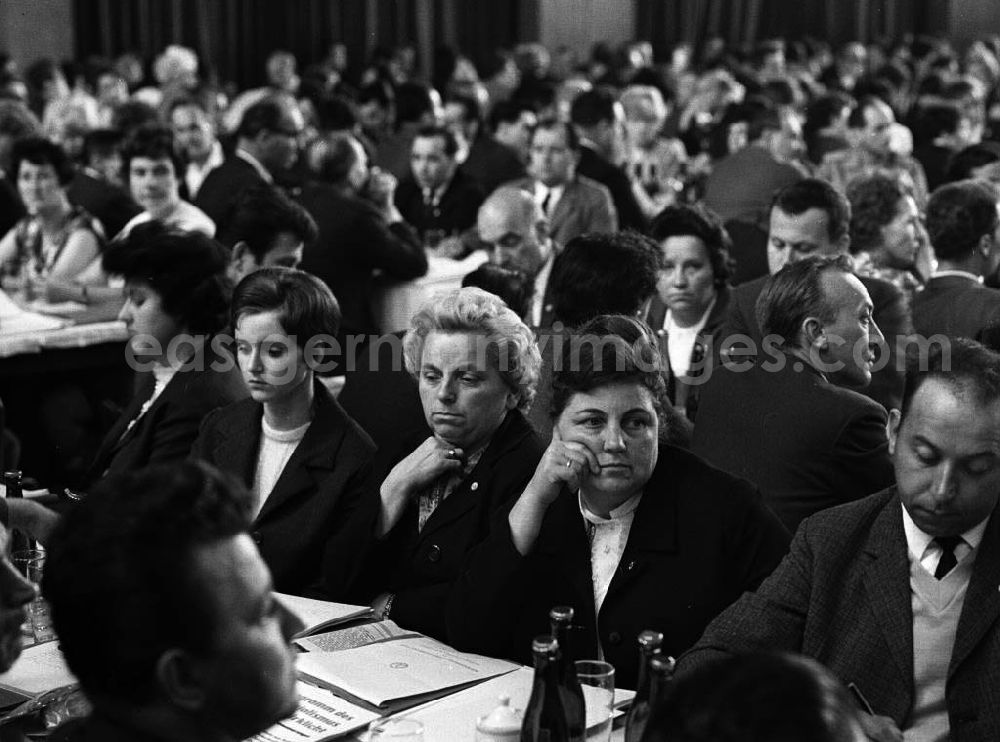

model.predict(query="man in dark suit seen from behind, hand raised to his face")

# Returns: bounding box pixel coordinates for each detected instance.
[299,136,427,339]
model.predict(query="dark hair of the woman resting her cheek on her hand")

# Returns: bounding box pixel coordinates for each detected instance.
[550,314,667,424]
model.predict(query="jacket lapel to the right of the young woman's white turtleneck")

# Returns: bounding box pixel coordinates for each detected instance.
[257,390,346,522]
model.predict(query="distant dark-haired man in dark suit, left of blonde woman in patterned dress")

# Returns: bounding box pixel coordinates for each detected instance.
[570,90,647,232]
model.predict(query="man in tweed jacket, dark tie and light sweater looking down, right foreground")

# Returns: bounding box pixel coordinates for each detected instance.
[679,341,1000,742]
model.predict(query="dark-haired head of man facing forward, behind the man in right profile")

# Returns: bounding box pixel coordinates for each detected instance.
[767,178,851,275]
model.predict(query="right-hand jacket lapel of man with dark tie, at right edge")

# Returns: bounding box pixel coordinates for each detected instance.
[948,510,1000,677]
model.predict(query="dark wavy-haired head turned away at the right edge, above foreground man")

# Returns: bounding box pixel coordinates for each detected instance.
[927,180,1000,276]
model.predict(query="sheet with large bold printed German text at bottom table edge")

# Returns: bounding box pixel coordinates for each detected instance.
[249,681,379,742]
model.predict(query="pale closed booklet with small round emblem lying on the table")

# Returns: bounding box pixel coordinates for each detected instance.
[298,637,518,706]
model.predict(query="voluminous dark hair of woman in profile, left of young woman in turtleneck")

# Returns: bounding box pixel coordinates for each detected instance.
[102,221,232,335]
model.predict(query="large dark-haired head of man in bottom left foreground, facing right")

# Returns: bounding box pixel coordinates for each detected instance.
[43,463,301,740]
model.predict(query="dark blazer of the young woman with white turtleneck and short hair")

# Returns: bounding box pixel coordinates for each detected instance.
[191,381,378,601]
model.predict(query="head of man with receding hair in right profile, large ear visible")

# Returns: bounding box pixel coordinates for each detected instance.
[756,255,884,388]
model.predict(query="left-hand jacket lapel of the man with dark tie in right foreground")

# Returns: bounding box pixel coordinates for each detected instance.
[864,497,913,687]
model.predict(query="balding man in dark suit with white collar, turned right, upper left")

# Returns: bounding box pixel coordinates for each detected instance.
[194,98,304,234]
